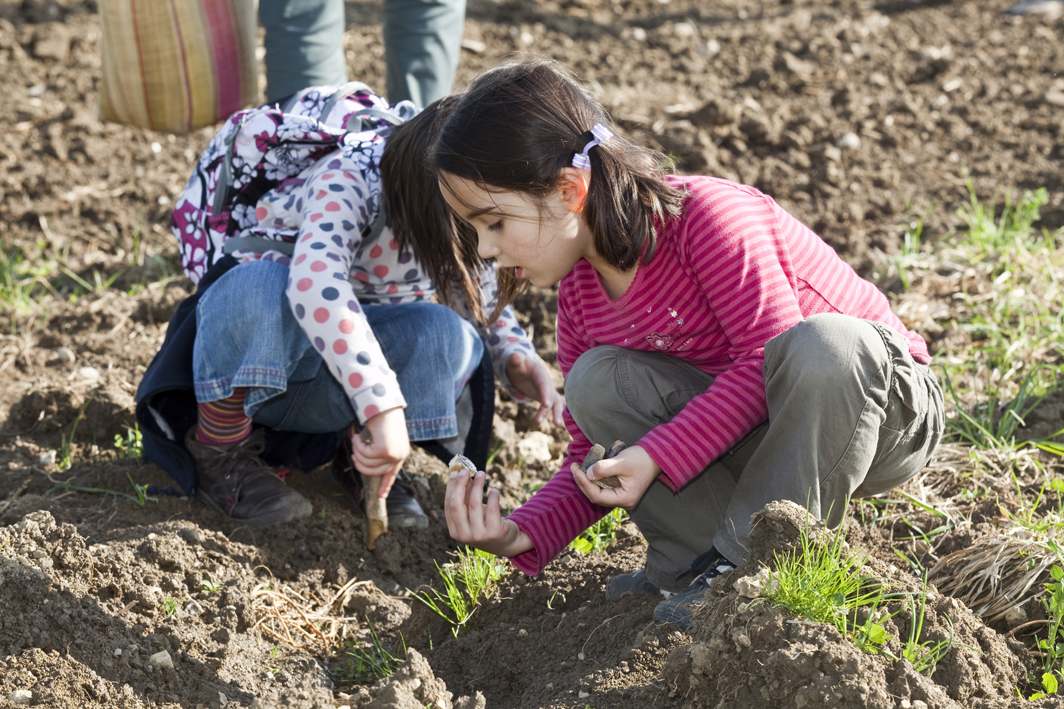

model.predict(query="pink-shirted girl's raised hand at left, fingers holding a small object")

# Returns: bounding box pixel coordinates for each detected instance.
[444,471,533,557]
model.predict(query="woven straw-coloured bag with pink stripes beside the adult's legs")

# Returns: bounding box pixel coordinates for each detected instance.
[99,0,260,133]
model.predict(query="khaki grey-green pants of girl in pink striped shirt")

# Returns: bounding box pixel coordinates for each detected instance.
[565,314,944,591]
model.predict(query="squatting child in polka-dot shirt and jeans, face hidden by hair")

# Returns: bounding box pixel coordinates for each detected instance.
[174,89,564,526]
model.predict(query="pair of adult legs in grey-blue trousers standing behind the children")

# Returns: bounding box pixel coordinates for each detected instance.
[259,0,465,106]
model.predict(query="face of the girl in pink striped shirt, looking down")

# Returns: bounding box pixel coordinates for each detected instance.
[439,172,594,287]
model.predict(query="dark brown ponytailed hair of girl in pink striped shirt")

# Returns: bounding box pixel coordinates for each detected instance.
[432,60,683,303]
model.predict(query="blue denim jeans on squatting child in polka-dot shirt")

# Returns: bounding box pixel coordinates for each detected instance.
[193,256,484,441]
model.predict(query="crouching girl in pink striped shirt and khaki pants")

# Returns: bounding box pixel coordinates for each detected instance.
[433,62,943,626]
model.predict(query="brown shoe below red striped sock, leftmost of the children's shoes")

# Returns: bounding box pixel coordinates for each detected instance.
[185,426,314,527]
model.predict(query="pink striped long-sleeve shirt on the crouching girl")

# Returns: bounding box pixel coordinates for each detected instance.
[510,177,930,574]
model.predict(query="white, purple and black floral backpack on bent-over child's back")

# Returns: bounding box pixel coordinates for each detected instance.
[170,82,416,283]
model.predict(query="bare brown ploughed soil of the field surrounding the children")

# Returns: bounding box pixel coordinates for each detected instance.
[0,0,1064,707]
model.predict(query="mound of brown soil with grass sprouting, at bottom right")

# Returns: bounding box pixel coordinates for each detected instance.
[664,502,1023,709]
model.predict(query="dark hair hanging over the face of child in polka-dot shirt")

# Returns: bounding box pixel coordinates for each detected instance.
[381,96,484,320]
